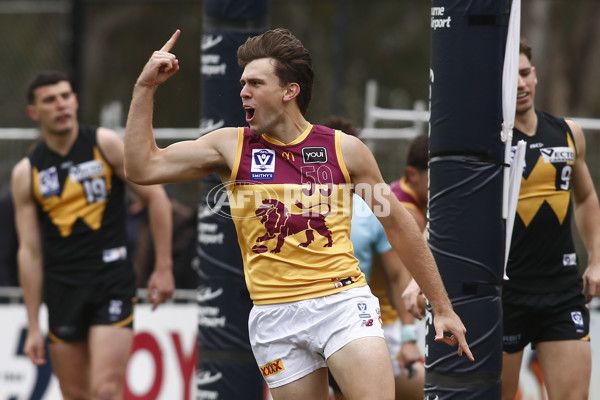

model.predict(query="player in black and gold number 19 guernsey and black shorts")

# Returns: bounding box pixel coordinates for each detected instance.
[11,71,175,399]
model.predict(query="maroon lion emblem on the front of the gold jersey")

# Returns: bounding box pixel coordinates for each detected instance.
[252,199,333,253]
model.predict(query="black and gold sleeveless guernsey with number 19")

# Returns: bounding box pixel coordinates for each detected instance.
[28,126,127,283]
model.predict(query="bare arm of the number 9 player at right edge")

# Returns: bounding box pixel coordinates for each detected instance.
[567,120,600,302]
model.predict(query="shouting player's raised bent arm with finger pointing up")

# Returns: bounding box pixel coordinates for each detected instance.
[125,30,241,185]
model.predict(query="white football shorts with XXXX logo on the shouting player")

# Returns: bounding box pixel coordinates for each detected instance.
[248,286,384,388]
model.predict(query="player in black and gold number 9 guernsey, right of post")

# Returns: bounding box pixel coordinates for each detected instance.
[502,41,600,400]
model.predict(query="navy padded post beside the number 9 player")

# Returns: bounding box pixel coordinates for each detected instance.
[425,0,509,399]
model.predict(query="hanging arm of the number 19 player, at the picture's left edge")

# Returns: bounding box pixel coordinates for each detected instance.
[11,158,46,365]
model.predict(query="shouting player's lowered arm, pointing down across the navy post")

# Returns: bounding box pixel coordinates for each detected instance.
[342,135,473,360]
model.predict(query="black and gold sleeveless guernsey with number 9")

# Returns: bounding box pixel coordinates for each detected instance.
[504,110,581,293]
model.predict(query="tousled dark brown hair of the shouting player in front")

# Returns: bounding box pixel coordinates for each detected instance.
[237,28,314,115]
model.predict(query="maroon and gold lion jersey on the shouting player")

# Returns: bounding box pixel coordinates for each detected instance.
[226,124,366,304]
